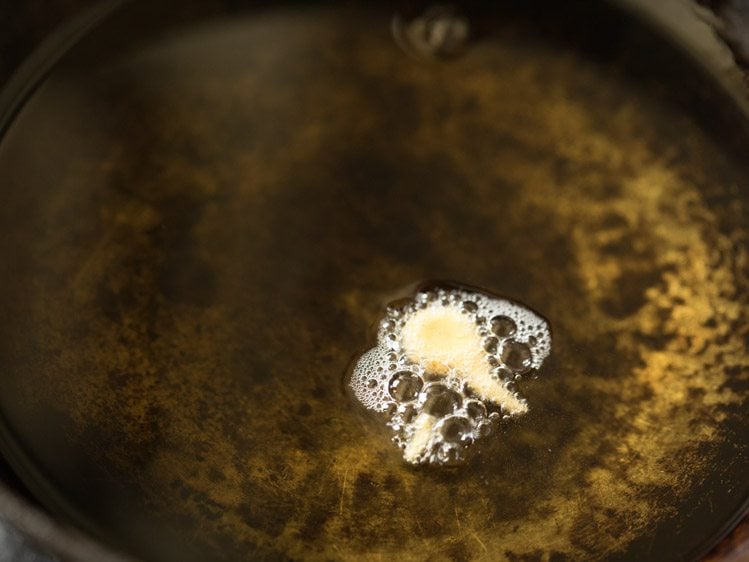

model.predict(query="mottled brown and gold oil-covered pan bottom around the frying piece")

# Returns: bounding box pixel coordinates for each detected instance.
[0,3,749,561]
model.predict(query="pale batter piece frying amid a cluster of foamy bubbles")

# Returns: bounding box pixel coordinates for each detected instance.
[351,288,551,466]
